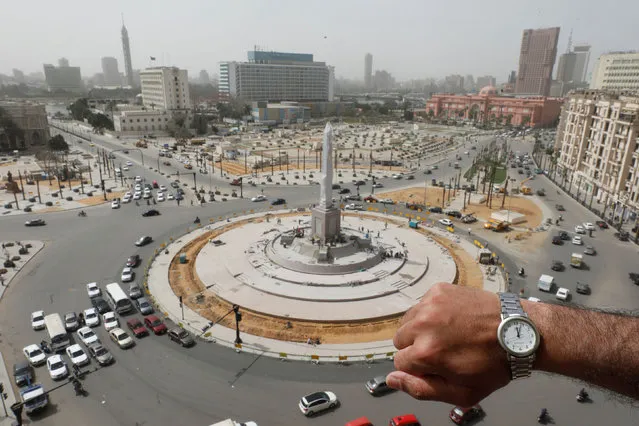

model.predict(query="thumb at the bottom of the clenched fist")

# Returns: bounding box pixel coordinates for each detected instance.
[386,371,460,403]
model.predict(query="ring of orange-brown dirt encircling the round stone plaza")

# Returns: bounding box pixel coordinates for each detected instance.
[169,213,483,343]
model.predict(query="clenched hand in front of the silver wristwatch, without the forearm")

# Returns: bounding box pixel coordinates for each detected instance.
[386,283,510,407]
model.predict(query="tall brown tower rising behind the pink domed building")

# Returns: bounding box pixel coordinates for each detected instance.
[515,27,559,96]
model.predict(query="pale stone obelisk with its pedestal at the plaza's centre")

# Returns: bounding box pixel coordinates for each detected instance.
[311,123,340,243]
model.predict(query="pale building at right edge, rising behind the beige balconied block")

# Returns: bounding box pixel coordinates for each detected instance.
[590,52,639,91]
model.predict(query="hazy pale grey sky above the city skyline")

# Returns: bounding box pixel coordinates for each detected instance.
[0,0,639,81]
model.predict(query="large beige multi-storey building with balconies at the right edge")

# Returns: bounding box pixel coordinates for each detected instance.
[555,90,639,218]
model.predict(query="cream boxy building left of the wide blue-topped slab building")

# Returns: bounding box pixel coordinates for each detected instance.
[140,67,191,110]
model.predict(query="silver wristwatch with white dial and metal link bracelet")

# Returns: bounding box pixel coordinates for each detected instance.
[497,293,541,379]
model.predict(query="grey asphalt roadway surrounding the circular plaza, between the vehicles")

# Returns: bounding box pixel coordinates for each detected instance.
[0,131,639,426]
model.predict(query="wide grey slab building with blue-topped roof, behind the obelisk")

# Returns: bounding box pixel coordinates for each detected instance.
[219,51,331,102]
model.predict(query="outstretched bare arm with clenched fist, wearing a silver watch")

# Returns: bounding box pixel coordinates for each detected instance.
[386,283,639,407]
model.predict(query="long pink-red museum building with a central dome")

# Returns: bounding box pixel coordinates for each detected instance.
[426,86,563,127]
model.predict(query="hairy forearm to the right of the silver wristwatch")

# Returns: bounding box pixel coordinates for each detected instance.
[522,301,639,399]
